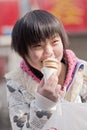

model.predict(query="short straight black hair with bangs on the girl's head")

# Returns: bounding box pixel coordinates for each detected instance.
[11,10,68,58]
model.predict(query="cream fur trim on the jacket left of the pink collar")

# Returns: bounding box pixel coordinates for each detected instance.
[5,68,38,96]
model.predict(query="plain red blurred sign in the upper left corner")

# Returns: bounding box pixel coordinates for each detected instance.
[0,0,19,34]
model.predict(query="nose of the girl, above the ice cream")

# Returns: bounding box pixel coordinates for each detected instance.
[44,44,54,58]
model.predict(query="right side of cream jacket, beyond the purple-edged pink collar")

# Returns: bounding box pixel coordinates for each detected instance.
[65,60,87,102]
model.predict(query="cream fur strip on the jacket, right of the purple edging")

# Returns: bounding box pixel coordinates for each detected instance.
[65,70,83,103]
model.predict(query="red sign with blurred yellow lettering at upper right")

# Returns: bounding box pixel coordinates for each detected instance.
[31,0,87,32]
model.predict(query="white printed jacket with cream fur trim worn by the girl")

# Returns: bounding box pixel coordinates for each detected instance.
[5,61,87,130]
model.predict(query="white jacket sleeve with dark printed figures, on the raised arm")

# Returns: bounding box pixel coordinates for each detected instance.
[7,80,56,130]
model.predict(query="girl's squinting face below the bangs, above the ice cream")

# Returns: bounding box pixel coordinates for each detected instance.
[26,35,63,70]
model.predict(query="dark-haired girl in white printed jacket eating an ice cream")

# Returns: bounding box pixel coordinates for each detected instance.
[6,10,87,130]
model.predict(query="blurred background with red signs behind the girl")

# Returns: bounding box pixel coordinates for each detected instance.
[0,0,87,130]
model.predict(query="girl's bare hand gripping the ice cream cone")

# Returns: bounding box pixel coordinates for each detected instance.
[37,73,62,102]
